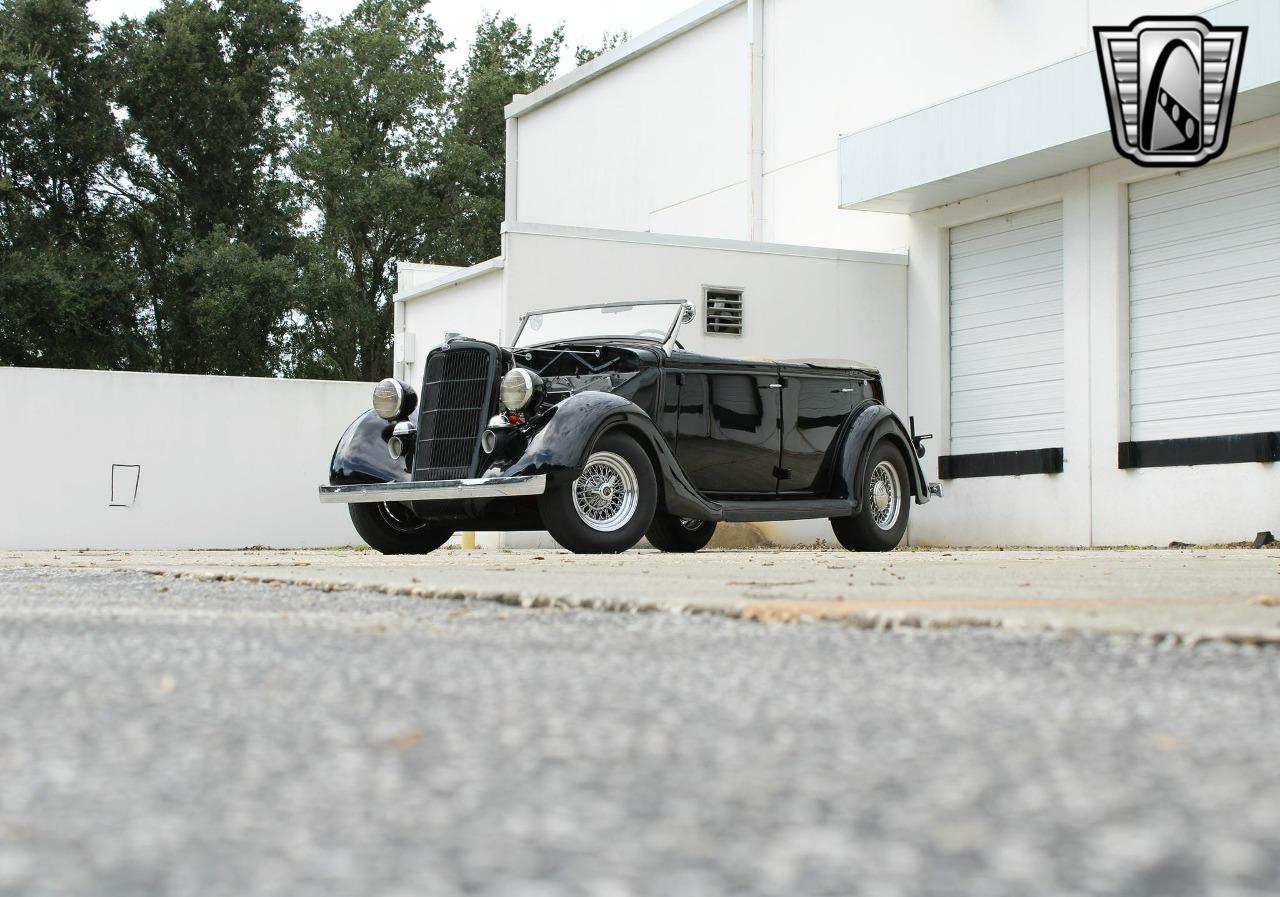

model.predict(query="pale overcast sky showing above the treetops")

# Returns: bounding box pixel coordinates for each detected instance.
[88,0,696,68]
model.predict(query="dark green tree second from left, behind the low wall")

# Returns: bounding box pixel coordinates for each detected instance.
[108,0,303,375]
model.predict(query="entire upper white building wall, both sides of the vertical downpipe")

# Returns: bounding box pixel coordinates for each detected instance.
[507,0,1206,250]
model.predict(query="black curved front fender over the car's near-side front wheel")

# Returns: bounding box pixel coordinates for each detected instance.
[503,392,719,520]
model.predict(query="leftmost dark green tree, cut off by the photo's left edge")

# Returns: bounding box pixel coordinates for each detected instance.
[0,0,148,369]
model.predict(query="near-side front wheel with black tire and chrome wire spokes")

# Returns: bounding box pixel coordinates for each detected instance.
[538,431,658,554]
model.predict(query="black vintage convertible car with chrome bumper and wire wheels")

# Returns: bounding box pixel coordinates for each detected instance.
[320,301,942,554]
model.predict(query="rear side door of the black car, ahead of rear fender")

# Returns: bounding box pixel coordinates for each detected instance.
[778,369,865,494]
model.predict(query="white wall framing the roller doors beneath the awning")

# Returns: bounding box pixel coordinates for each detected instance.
[906,118,1280,545]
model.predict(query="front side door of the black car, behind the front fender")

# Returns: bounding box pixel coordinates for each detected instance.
[676,361,782,498]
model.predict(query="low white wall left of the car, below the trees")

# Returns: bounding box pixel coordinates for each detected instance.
[0,367,370,549]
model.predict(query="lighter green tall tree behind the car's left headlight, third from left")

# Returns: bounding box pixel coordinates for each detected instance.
[291,0,448,380]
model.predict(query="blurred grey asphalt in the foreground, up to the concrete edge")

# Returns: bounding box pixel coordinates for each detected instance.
[0,571,1280,897]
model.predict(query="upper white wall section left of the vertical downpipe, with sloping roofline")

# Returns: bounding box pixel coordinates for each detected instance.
[507,6,749,238]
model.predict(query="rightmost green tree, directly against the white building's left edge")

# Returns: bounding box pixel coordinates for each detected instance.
[430,15,564,265]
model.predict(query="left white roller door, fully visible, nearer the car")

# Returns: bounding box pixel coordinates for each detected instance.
[951,203,1062,454]
